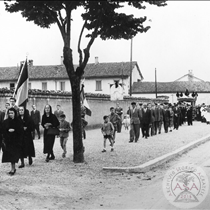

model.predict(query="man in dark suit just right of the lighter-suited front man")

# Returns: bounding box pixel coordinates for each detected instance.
[141,103,152,139]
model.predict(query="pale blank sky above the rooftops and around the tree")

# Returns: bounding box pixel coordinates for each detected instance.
[0,1,210,82]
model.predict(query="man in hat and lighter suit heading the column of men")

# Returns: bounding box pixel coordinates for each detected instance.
[129,102,141,143]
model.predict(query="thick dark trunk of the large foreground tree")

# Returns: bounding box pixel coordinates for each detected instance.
[63,47,84,163]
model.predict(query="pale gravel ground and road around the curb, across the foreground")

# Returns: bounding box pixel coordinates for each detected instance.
[0,123,210,210]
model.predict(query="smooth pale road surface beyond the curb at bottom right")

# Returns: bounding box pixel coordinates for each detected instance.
[90,142,210,210]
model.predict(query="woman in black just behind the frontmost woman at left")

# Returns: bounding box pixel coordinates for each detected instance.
[18,106,35,168]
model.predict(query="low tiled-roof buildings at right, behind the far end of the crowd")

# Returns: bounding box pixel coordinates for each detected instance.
[132,71,210,105]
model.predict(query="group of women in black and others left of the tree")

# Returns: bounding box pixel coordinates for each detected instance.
[0,97,71,176]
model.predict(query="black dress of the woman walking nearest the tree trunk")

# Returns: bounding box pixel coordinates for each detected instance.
[42,114,59,154]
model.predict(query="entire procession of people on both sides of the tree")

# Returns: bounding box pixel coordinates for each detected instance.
[0,95,207,175]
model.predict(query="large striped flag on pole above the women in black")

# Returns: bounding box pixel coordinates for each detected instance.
[13,59,29,107]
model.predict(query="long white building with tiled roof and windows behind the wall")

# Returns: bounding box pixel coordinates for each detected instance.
[0,59,143,95]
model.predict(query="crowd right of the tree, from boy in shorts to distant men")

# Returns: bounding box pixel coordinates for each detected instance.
[101,102,196,152]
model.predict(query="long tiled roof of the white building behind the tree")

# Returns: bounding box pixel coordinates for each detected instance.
[0,61,139,81]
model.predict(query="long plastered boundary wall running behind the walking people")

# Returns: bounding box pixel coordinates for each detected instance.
[0,92,165,128]
